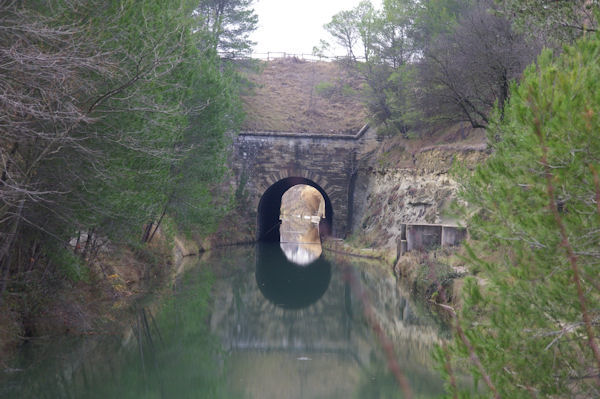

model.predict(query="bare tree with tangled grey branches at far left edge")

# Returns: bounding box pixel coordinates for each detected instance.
[0,2,115,293]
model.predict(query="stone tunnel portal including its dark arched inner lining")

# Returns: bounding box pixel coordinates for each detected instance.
[231,125,375,241]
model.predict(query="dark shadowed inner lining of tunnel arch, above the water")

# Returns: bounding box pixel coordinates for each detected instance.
[256,177,333,242]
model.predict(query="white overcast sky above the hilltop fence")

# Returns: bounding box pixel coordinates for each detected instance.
[251,0,381,55]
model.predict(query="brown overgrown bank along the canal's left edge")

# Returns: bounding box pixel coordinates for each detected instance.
[0,227,198,364]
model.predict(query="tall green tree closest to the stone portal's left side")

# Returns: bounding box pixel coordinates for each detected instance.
[168,52,242,234]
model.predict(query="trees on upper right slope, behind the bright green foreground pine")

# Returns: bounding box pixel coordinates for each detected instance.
[314,0,598,136]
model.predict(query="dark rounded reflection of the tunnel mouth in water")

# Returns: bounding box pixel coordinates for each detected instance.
[256,243,331,309]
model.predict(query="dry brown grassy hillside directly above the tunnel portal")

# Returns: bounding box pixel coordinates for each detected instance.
[242,58,367,134]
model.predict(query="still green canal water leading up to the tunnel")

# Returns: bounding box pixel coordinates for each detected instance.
[0,243,446,399]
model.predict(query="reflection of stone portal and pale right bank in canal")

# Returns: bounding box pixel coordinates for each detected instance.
[211,244,443,399]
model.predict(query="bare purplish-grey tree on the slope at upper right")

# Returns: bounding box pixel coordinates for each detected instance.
[419,0,540,127]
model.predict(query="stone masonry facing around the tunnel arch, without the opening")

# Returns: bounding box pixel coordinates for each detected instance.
[231,132,372,237]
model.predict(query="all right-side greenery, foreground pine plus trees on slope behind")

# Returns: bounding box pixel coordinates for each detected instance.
[326,0,600,398]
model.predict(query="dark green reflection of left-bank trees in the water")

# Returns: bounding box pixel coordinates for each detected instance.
[0,268,237,399]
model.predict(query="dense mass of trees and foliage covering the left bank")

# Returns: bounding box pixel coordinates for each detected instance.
[0,0,256,354]
